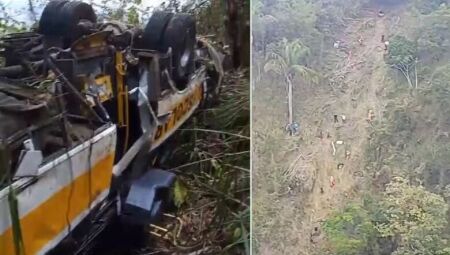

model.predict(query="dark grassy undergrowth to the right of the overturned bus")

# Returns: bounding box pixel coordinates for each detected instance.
[167,71,250,254]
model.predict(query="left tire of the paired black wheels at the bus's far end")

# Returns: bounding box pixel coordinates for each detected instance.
[143,11,173,51]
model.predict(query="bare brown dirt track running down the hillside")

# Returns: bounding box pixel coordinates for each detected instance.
[299,9,388,254]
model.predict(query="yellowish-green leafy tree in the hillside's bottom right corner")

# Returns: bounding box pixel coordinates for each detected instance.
[377,177,448,255]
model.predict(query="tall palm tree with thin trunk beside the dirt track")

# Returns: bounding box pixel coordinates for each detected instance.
[264,38,319,135]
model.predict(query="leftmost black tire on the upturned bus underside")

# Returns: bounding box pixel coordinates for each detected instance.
[39,0,97,42]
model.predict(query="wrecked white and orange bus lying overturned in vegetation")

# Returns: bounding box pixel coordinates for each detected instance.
[0,1,223,255]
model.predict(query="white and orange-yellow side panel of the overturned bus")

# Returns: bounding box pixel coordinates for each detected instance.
[0,126,116,255]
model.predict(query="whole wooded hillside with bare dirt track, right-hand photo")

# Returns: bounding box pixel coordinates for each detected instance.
[252,0,450,255]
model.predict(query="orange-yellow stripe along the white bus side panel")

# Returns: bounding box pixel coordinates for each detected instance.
[0,154,114,255]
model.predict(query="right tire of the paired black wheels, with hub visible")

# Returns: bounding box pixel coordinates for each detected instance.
[164,14,197,83]
